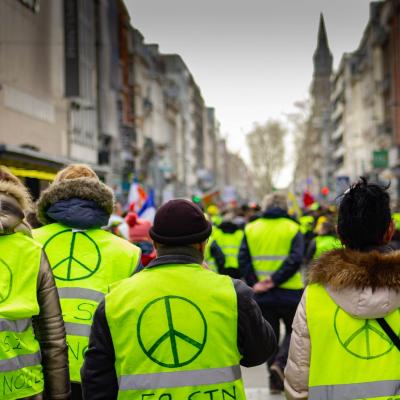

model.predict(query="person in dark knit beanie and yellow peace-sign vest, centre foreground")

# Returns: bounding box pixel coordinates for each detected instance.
[82,200,276,400]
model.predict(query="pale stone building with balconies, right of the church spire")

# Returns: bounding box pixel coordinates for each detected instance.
[332,1,399,197]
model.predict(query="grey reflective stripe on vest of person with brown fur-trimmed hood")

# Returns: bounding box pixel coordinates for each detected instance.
[309,380,400,400]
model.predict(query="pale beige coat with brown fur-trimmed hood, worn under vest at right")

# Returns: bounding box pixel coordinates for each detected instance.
[285,247,400,400]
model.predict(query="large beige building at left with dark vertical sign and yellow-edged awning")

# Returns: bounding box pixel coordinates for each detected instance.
[0,0,135,195]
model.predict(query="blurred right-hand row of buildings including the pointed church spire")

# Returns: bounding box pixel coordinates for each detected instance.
[294,0,400,200]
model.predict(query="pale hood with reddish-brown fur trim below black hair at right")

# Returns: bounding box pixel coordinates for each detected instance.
[309,249,400,318]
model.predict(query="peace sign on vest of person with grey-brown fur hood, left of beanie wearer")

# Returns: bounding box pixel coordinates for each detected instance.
[43,229,101,281]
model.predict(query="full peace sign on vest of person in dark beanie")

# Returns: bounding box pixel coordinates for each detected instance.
[137,296,207,368]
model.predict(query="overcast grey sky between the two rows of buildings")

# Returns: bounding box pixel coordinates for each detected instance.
[125,0,369,186]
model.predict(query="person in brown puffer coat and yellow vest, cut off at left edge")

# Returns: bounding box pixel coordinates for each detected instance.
[0,166,70,400]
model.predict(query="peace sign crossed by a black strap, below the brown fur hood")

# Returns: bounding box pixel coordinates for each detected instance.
[334,307,400,360]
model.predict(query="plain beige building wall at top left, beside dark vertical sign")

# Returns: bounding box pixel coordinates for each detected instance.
[0,0,67,156]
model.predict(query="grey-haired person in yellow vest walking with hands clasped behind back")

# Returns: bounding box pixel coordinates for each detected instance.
[239,192,304,393]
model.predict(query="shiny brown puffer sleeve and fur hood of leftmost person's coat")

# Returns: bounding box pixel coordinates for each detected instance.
[0,181,70,400]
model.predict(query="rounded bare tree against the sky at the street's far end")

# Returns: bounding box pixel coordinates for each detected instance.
[246,119,287,197]
